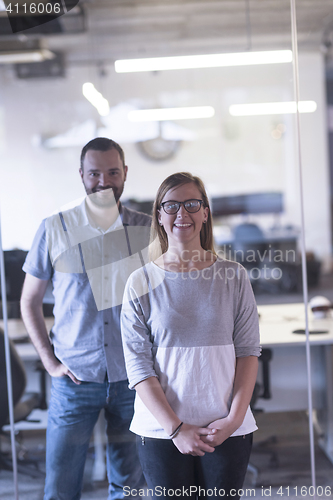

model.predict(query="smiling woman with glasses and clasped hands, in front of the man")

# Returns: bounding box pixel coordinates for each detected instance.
[122,172,260,498]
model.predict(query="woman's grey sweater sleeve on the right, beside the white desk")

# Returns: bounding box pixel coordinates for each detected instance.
[233,266,261,358]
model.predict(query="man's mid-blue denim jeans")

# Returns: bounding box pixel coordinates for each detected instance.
[44,377,143,500]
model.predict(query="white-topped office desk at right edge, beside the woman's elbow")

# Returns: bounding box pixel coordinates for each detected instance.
[258,304,333,463]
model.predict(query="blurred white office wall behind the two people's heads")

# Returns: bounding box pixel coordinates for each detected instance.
[0,53,331,268]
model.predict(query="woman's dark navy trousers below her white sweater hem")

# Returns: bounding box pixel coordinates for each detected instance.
[137,433,253,500]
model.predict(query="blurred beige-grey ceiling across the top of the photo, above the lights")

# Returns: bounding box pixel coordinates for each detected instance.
[0,0,333,65]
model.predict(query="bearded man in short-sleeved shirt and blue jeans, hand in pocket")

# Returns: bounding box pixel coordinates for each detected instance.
[21,138,151,500]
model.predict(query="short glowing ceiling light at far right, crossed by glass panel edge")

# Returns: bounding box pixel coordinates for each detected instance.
[229,101,317,116]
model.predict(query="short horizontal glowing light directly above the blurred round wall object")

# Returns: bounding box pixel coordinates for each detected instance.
[128,106,215,122]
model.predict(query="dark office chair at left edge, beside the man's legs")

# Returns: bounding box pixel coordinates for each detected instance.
[0,328,44,477]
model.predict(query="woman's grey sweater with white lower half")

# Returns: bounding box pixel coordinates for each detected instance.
[121,259,260,438]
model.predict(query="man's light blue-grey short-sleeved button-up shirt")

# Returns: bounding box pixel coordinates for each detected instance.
[23,202,151,382]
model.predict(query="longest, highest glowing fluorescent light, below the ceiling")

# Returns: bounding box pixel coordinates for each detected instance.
[115,50,292,73]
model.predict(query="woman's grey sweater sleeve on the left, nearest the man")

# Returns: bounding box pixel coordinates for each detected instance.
[121,269,157,389]
